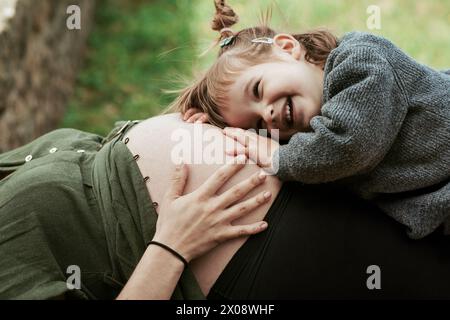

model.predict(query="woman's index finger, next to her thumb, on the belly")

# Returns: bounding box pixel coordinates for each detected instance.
[197,155,247,198]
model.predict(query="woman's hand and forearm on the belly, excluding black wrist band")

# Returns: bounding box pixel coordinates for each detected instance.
[117,156,271,299]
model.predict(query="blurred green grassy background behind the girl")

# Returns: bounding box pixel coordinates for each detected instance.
[61,0,450,134]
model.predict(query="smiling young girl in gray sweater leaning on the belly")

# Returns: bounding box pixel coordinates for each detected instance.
[173,0,450,239]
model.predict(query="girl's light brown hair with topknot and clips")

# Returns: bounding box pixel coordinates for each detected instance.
[168,0,337,128]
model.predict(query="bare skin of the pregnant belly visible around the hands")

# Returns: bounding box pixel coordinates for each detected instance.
[119,116,281,295]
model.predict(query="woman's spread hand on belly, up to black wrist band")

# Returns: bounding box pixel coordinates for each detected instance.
[153,156,271,261]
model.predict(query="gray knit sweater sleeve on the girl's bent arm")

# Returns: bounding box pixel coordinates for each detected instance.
[273,46,406,183]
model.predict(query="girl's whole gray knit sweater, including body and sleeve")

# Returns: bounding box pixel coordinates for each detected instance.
[274,32,450,239]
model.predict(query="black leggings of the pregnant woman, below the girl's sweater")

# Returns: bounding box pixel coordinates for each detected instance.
[207,183,450,300]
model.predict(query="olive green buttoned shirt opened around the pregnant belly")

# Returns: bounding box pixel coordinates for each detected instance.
[0,122,204,299]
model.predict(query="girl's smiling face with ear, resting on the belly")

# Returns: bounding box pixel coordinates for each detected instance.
[221,34,323,140]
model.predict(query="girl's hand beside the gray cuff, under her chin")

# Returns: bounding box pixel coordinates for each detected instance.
[222,128,280,174]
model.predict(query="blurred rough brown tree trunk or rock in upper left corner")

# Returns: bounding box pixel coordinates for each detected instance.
[0,0,95,152]
